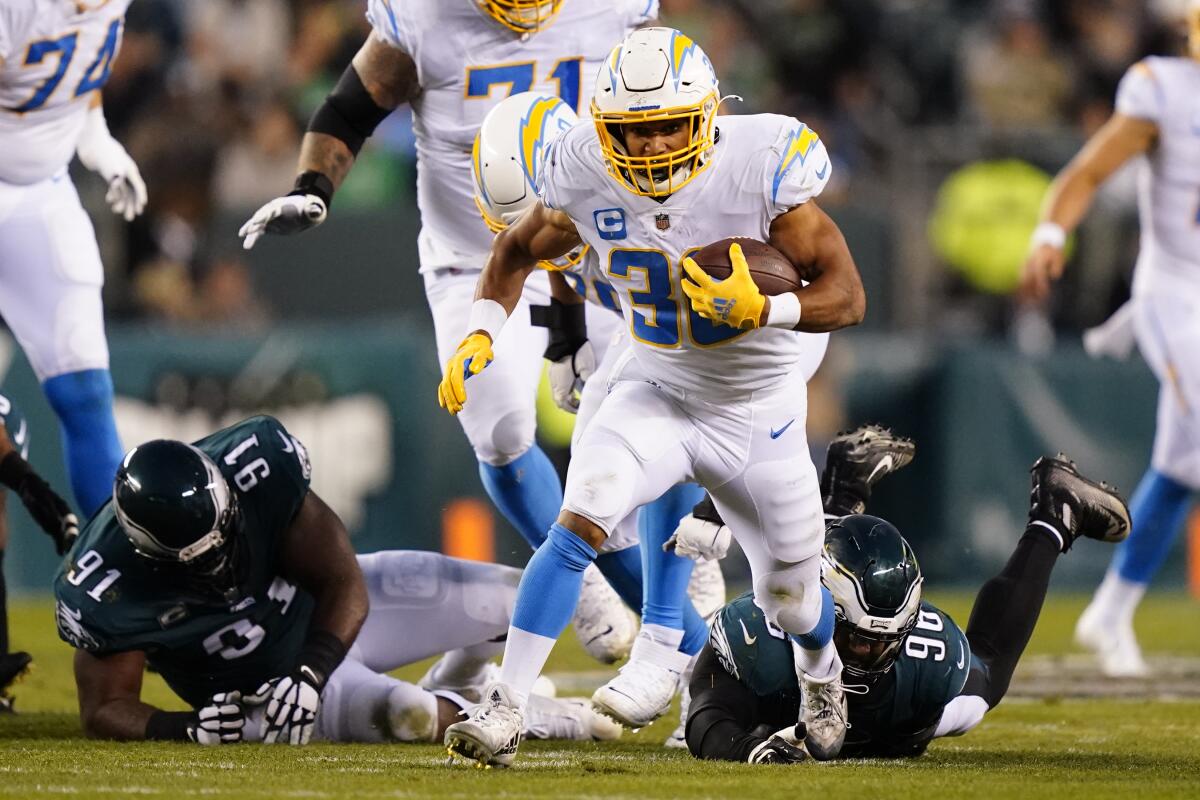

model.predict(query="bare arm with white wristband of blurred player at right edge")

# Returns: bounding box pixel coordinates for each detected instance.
[1020,114,1158,300]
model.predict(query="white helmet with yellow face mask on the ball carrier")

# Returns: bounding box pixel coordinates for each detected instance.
[592,28,720,197]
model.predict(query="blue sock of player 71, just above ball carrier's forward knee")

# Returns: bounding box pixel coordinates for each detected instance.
[479,445,563,548]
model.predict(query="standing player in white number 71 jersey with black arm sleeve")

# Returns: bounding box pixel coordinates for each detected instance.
[240,0,659,657]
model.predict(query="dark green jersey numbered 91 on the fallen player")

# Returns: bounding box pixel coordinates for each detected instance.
[54,416,313,706]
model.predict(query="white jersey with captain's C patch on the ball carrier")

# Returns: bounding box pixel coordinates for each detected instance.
[539,114,830,393]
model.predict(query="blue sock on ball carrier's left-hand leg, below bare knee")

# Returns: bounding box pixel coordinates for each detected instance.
[512,523,596,639]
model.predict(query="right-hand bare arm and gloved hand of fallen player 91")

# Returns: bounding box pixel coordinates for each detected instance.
[246,492,367,745]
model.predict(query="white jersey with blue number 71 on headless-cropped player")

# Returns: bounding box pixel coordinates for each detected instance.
[367,0,659,272]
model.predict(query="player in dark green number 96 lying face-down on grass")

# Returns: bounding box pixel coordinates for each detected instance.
[677,426,1129,763]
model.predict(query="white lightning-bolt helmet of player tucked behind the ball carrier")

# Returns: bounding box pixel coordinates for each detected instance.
[470,91,587,271]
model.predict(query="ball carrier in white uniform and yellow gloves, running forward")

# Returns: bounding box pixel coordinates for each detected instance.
[439,28,865,765]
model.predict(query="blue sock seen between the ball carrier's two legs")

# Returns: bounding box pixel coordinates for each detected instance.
[637,483,708,655]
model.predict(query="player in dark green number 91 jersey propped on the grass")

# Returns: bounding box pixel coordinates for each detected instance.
[54,416,620,745]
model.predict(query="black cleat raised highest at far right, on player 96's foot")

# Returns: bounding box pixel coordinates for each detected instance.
[1030,453,1130,553]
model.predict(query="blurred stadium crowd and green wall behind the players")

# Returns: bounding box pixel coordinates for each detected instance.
[0,0,1187,591]
